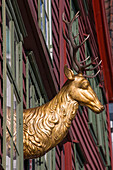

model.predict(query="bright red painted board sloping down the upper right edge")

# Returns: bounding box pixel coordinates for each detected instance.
[92,0,113,102]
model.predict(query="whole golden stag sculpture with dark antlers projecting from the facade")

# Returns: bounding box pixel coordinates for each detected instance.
[6,13,104,159]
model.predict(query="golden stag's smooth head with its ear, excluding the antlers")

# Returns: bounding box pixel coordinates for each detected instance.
[64,66,104,113]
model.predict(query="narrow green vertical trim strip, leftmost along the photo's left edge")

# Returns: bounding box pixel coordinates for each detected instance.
[2,0,7,169]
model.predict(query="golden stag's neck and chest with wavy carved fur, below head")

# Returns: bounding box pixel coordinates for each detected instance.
[23,82,78,158]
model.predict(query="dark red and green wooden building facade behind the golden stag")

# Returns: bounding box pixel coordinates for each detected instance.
[0,0,113,170]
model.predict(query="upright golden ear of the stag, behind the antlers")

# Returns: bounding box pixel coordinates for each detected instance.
[64,65,74,80]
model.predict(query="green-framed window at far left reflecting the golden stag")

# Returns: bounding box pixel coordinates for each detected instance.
[2,0,23,170]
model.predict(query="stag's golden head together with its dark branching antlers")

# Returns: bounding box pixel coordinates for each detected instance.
[62,12,104,113]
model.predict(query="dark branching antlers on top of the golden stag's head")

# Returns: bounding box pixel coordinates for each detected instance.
[62,11,102,78]
